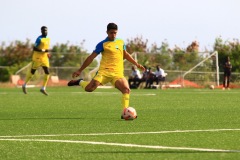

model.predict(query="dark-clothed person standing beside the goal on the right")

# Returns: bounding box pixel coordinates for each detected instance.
[222,56,232,90]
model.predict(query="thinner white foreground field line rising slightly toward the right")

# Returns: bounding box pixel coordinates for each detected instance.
[0,128,240,138]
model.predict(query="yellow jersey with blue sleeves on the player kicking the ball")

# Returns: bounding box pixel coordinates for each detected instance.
[94,38,126,76]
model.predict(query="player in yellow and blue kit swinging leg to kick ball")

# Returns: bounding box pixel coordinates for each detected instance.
[68,23,144,118]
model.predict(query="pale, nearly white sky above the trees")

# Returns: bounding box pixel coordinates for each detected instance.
[0,0,240,52]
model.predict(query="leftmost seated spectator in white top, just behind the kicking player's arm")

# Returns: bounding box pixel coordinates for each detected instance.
[128,66,142,88]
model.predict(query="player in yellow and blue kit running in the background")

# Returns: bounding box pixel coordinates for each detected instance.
[22,26,50,96]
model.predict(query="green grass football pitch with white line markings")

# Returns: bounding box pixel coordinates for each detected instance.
[0,87,240,160]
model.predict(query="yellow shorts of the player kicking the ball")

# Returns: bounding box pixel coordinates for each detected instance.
[93,72,124,87]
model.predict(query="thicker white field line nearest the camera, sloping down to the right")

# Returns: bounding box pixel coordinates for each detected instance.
[0,139,240,153]
